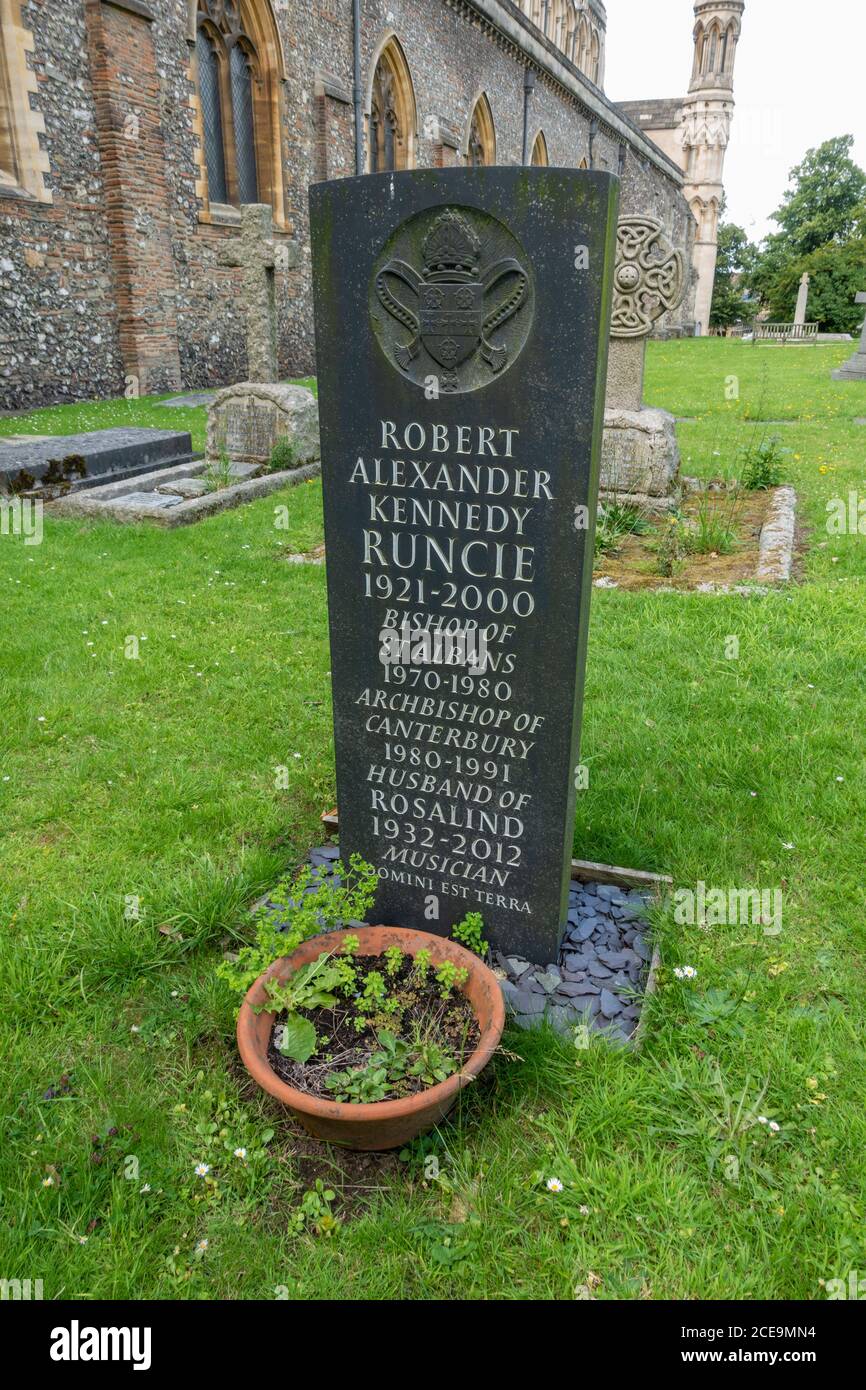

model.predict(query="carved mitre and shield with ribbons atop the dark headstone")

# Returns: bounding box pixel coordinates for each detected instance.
[375,207,528,392]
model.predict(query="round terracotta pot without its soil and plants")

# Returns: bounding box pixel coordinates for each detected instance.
[238,927,505,1150]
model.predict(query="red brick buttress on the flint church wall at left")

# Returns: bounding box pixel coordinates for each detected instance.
[85,0,182,395]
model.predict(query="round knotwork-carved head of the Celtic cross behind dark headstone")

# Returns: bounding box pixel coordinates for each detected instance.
[610,217,685,338]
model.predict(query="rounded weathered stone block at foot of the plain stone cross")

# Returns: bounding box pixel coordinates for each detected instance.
[207,381,320,468]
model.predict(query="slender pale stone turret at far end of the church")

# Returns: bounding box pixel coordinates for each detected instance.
[680,0,745,334]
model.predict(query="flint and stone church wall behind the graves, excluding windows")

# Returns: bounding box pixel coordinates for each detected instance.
[0,0,692,409]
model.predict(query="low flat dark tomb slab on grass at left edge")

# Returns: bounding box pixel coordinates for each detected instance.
[0,428,193,492]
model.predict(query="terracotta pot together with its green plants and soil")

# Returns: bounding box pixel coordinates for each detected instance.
[230,855,505,1148]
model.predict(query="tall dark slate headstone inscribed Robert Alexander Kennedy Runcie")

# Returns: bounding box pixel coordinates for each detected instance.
[310,168,619,960]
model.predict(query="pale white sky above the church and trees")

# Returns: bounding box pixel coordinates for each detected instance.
[605,0,866,240]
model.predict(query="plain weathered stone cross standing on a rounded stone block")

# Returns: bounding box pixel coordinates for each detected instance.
[220,203,297,381]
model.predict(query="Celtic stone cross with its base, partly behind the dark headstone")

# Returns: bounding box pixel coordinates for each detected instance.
[601,217,685,510]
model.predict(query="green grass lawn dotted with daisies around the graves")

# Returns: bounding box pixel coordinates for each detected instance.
[0,341,866,1300]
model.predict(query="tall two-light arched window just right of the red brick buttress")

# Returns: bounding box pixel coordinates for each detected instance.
[195,0,282,224]
